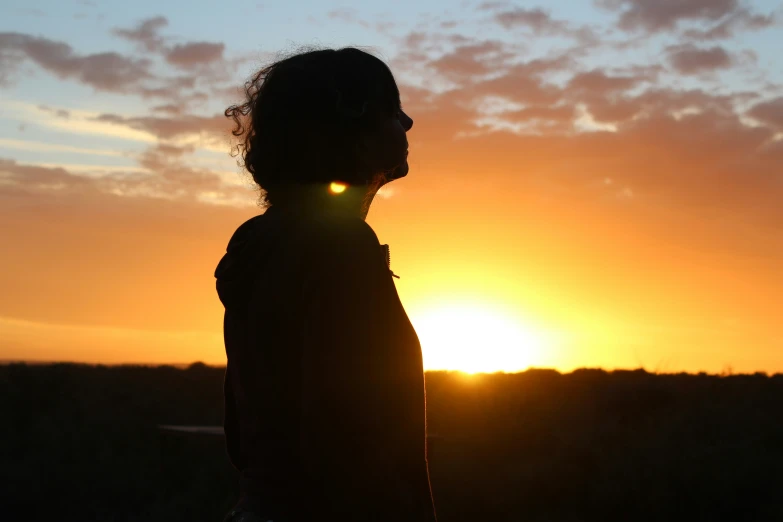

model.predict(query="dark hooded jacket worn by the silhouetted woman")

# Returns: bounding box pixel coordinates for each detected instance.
[215,207,435,522]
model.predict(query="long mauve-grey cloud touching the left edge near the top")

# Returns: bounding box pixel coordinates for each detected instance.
[0,33,152,93]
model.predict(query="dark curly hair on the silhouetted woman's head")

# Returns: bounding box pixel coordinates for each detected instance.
[225,47,400,204]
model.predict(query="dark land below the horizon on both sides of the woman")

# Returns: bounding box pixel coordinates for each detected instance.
[0,363,783,522]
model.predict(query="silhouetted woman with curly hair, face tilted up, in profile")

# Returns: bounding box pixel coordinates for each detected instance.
[215,48,435,522]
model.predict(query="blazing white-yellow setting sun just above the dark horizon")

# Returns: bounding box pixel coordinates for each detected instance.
[411,305,546,373]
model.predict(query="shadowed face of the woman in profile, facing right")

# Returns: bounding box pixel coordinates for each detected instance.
[363,104,413,181]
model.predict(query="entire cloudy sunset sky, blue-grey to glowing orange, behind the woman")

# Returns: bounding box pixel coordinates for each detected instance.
[0,0,783,373]
